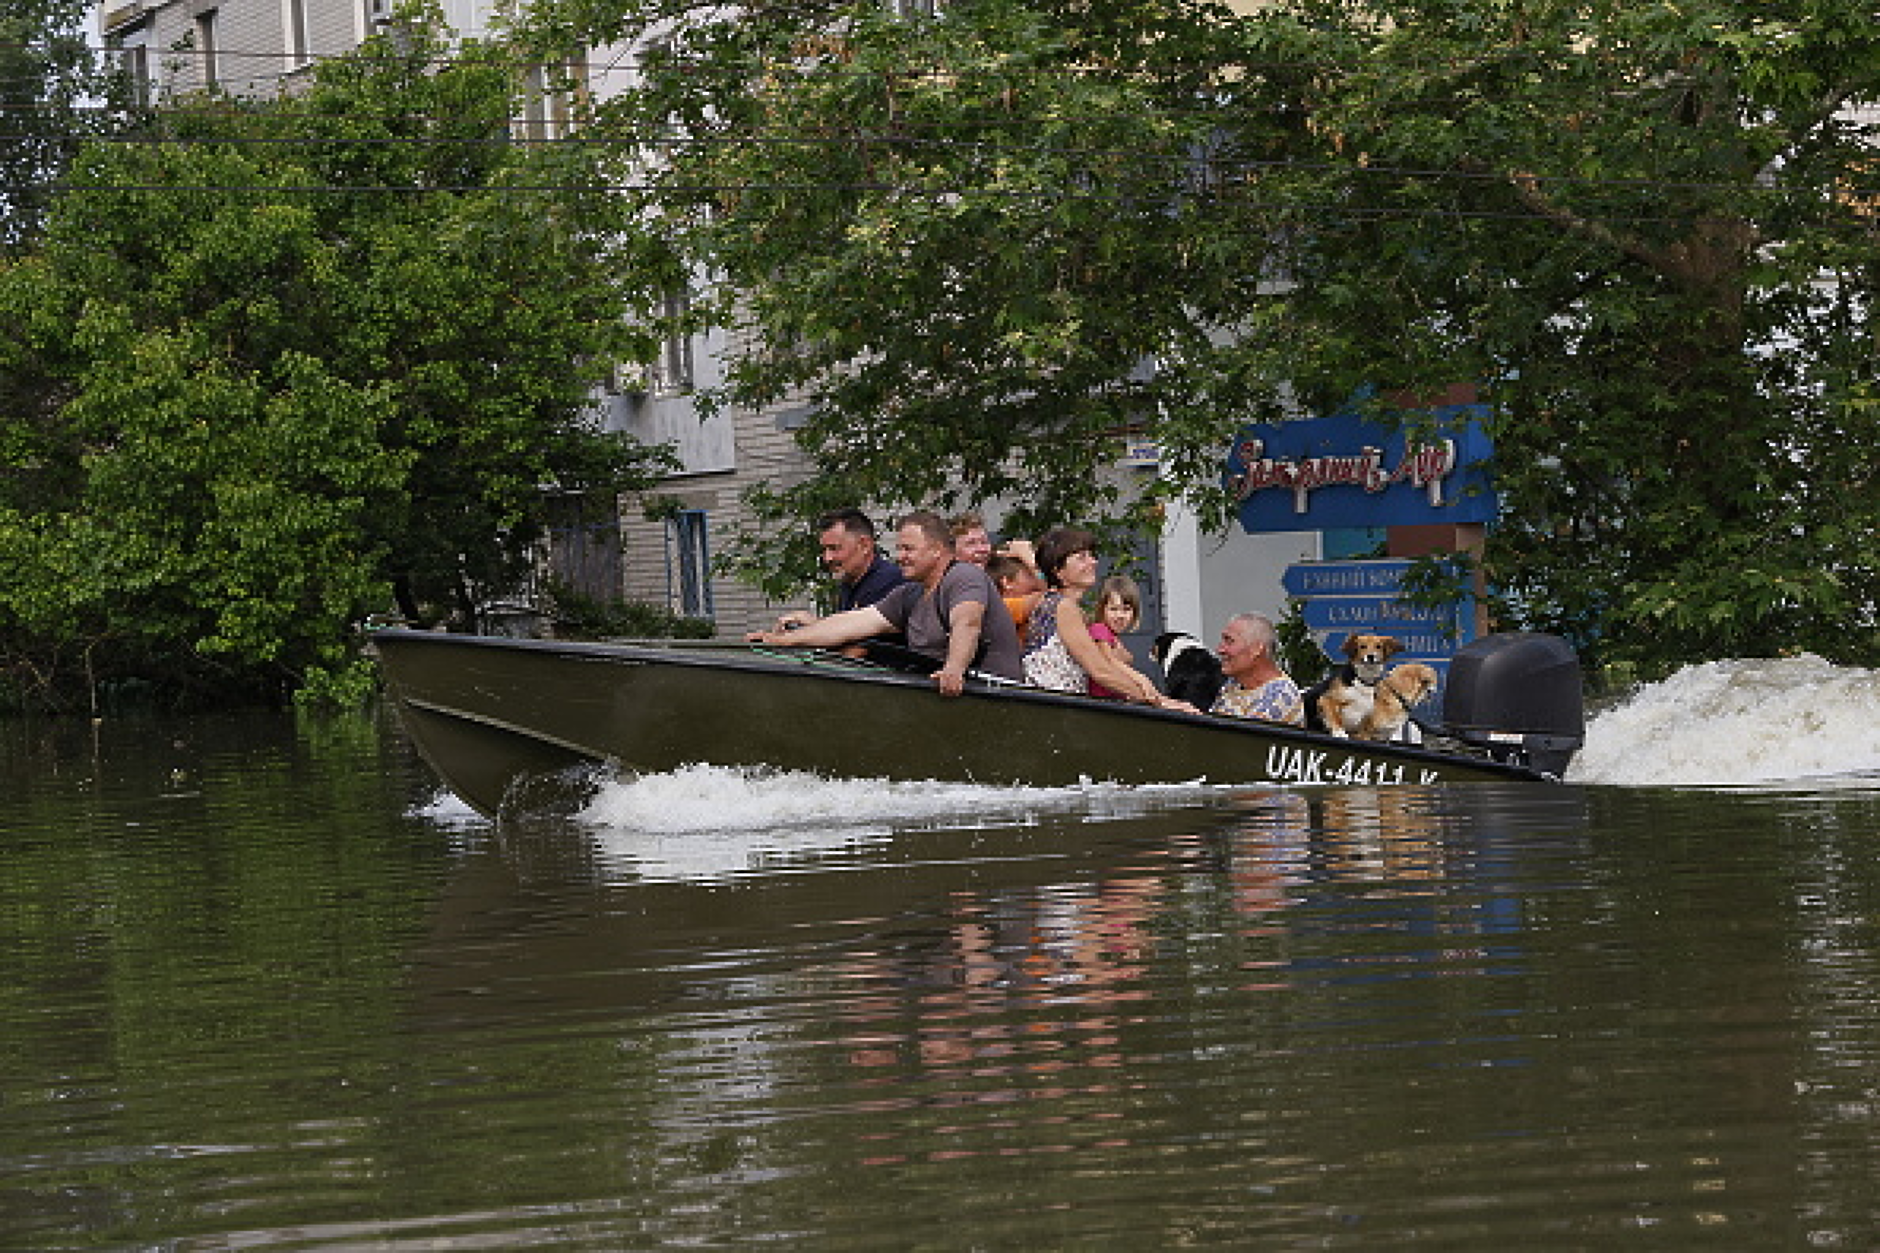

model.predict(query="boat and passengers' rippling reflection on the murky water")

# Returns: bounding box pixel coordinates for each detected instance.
[404,790,1609,1236]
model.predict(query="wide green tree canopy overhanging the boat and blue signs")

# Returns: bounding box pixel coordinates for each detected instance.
[538,0,1880,670]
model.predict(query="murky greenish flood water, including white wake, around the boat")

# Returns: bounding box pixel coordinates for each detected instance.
[0,662,1880,1249]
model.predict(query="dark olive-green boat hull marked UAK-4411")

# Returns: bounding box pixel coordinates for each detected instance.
[372,630,1551,815]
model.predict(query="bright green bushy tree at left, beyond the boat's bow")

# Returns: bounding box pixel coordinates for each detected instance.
[0,19,664,700]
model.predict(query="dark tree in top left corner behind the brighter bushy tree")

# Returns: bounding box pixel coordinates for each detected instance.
[0,0,111,254]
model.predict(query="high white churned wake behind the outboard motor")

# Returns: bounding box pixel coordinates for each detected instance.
[1566,655,1880,786]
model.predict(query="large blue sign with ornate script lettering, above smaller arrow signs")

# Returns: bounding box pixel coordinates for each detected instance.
[1224,404,1496,534]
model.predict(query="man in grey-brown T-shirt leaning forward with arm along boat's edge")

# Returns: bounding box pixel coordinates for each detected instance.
[748,512,1025,696]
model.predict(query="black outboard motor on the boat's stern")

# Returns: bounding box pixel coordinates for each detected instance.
[1442,632,1587,775]
